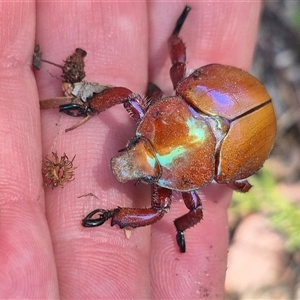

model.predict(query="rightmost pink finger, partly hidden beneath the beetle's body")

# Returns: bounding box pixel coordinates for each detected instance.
[149,2,260,299]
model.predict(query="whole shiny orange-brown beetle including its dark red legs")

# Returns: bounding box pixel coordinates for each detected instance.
[79,7,276,252]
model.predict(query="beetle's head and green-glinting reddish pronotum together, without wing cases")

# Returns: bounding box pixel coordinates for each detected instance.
[112,97,223,191]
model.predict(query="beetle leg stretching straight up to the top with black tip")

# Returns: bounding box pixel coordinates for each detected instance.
[168,6,191,89]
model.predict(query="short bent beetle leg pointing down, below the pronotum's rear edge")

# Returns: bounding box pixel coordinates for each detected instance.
[174,191,203,253]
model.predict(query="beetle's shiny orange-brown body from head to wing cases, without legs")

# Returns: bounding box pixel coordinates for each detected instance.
[112,64,276,191]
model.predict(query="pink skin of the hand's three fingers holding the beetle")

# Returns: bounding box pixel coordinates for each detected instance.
[0,1,260,299]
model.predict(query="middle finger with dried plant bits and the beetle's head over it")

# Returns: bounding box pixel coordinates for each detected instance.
[37,1,150,299]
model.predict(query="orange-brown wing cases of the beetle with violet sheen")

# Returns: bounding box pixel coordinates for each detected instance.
[176,64,276,183]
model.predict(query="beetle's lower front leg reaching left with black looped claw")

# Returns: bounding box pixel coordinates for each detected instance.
[82,185,172,228]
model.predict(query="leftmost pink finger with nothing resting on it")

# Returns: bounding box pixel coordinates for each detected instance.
[0,2,58,299]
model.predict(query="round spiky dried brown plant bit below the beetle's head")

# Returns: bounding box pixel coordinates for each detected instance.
[42,152,77,189]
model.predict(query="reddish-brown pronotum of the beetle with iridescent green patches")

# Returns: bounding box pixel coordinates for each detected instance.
[131,97,216,191]
